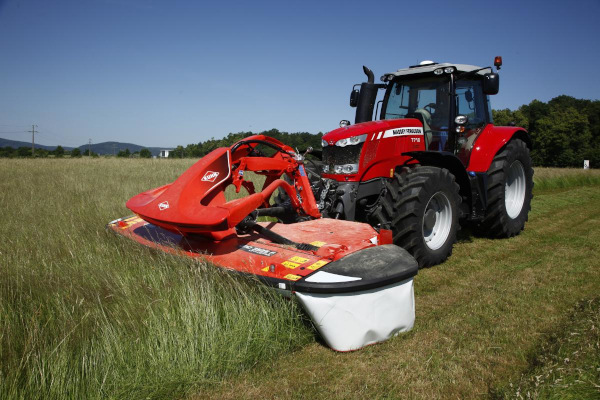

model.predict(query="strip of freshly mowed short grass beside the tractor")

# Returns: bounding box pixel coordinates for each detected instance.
[197,175,600,398]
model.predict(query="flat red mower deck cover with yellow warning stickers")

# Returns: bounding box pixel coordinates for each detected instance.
[109,217,391,282]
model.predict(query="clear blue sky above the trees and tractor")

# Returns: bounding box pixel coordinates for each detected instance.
[0,0,600,147]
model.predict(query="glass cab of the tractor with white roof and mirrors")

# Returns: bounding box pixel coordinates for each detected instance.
[350,57,502,165]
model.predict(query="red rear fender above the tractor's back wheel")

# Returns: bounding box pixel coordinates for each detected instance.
[467,126,532,172]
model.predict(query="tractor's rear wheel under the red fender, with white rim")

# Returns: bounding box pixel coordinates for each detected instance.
[478,139,533,238]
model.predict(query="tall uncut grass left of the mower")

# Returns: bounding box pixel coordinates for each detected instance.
[0,159,312,399]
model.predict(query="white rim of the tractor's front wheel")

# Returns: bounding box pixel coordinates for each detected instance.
[423,192,452,250]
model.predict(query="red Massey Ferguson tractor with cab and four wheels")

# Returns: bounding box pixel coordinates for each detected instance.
[292,57,533,267]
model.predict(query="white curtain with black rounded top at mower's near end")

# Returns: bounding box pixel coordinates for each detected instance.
[294,245,418,351]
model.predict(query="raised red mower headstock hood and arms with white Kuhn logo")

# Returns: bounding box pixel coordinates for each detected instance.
[126,135,321,240]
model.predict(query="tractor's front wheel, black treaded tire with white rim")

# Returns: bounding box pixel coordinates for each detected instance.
[369,167,461,268]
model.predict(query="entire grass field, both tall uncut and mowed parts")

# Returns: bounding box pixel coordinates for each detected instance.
[0,159,600,399]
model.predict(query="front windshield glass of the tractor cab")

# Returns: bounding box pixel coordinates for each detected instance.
[382,76,450,151]
